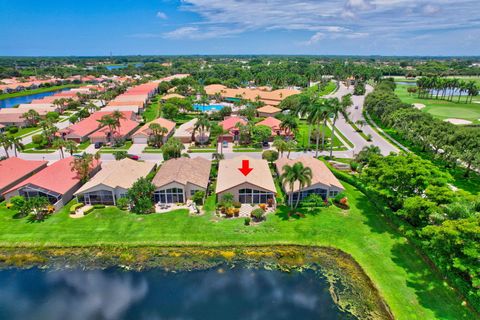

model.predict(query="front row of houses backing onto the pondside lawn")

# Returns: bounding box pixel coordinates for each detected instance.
[0,156,344,209]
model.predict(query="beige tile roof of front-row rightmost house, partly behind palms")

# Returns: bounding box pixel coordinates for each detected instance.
[275,156,345,191]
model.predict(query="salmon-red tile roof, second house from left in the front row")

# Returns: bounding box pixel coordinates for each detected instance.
[4,157,100,194]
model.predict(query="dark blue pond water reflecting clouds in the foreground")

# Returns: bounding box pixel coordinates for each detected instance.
[0,268,352,320]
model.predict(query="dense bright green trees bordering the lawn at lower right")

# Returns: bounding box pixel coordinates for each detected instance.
[348,146,480,307]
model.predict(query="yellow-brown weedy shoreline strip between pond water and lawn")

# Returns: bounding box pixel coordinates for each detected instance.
[0,245,394,319]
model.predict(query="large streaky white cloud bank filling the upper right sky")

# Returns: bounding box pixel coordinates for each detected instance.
[157,0,480,44]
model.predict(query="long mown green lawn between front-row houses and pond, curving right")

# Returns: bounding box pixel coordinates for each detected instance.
[0,185,475,320]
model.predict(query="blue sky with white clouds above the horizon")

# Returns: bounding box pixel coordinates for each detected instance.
[0,0,480,56]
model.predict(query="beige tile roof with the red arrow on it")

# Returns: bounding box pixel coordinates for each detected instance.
[215,156,277,193]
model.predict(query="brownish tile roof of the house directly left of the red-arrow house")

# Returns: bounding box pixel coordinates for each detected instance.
[152,157,212,188]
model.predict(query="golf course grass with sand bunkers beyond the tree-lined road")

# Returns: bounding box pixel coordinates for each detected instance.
[395,85,480,123]
